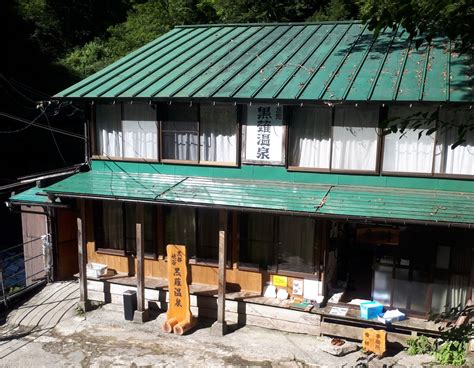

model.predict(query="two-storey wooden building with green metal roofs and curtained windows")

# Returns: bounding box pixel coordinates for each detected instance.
[11,22,474,341]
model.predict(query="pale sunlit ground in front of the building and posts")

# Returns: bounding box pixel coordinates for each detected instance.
[0,305,452,367]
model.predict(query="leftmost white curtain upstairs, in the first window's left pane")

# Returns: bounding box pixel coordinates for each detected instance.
[95,104,123,157]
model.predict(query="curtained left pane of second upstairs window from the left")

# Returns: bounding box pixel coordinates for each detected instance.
[163,121,199,161]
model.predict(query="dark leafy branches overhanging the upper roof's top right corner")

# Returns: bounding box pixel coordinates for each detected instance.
[361,0,474,51]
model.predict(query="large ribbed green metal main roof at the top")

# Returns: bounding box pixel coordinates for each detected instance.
[55,22,473,102]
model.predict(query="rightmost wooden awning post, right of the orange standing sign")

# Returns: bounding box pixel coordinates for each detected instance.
[211,210,227,336]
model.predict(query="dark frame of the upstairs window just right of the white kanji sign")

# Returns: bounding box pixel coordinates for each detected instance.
[287,105,382,175]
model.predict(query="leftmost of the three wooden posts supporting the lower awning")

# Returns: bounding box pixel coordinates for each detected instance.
[77,199,90,312]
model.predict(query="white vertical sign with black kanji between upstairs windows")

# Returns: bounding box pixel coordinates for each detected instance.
[244,104,284,164]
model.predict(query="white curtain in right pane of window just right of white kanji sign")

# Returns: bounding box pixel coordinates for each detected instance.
[332,107,379,171]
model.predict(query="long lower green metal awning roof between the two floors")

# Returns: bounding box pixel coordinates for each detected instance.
[40,170,474,227]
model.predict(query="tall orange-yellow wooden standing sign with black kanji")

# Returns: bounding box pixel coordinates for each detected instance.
[163,244,195,335]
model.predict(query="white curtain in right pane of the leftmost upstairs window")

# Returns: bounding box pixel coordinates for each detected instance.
[122,103,158,160]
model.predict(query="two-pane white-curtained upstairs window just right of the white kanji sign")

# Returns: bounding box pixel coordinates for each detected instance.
[289,107,379,171]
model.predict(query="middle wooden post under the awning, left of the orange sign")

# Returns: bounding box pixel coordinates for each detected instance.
[133,203,148,323]
